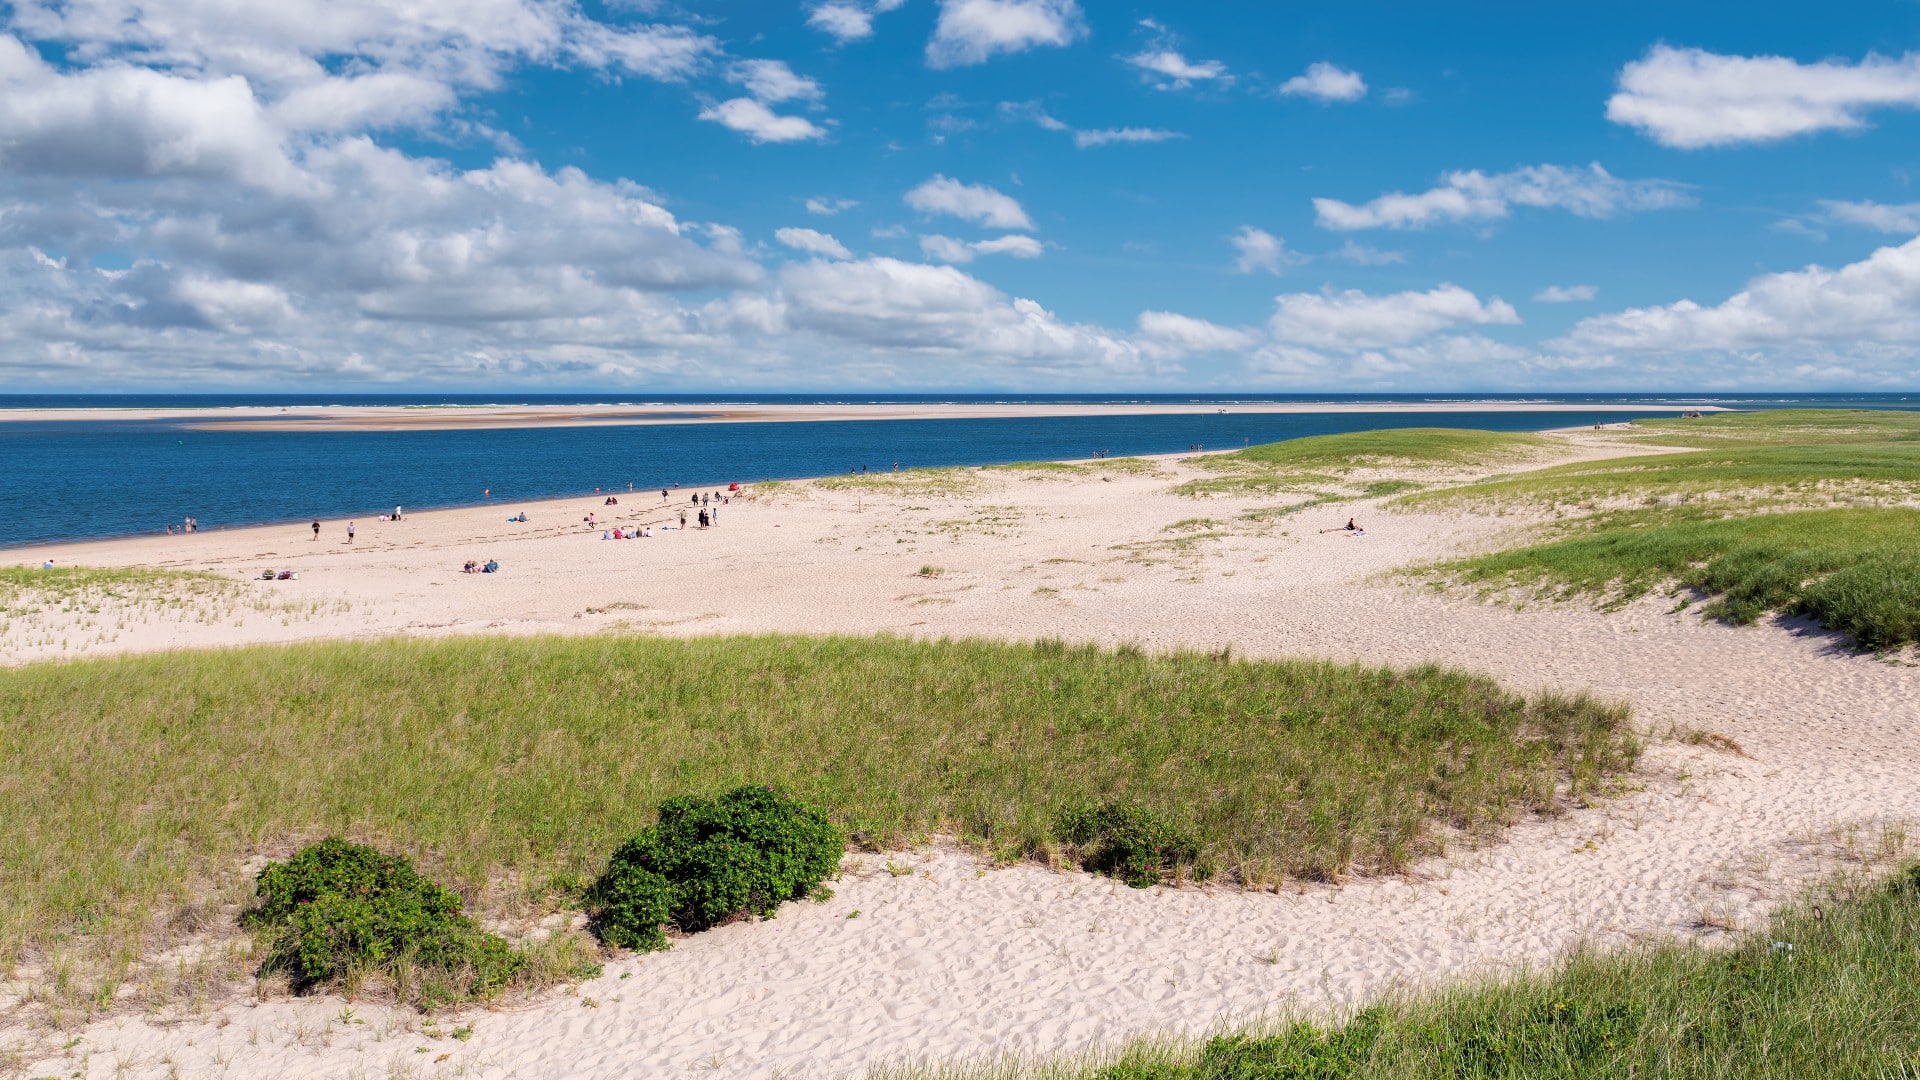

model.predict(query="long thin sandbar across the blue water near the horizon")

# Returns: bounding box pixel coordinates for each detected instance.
[0,400,1722,430]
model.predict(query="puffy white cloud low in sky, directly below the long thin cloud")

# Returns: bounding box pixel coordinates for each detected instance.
[1267,284,1521,350]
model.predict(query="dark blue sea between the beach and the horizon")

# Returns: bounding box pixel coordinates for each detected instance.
[0,394,1920,546]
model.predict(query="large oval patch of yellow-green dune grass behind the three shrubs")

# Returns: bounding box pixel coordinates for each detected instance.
[0,636,1636,999]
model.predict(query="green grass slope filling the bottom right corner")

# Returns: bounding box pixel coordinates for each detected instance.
[868,857,1920,1080]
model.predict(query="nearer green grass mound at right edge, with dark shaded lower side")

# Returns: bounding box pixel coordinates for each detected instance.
[1432,507,1920,650]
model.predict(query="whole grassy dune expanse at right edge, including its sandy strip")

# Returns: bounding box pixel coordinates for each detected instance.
[1396,409,1920,648]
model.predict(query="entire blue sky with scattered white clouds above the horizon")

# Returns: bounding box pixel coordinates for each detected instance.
[0,0,1920,392]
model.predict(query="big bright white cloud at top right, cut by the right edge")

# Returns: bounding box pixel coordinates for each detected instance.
[1607,44,1920,150]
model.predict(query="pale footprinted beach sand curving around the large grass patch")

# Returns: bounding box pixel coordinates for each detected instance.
[0,434,1920,1078]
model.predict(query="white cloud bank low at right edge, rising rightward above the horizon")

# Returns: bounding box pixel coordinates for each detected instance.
[1553,238,1920,353]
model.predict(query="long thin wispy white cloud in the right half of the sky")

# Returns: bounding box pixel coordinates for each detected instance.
[1313,163,1693,231]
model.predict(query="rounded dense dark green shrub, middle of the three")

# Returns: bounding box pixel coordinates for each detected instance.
[588,784,847,951]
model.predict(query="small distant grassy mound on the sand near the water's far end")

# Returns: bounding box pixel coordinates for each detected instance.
[1175,427,1557,496]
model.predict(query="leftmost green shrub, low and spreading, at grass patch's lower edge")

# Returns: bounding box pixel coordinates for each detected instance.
[242,838,524,999]
